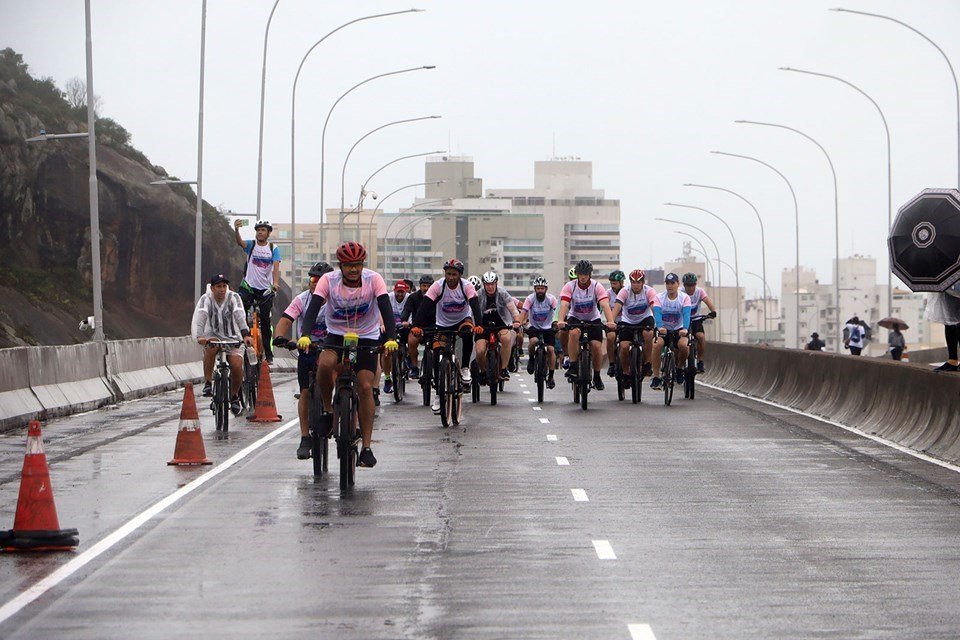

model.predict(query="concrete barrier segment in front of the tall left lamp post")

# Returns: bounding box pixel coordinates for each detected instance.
[27,342,117,418]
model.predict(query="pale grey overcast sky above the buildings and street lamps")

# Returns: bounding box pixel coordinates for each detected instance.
[0,0,960,292]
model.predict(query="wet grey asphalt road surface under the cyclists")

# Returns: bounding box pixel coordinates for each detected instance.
[0,373,960,640]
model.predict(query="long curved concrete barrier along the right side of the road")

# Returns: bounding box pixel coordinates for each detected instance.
[703,343,960,463]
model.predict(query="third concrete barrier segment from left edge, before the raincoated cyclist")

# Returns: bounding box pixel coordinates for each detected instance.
[104,338,179,400]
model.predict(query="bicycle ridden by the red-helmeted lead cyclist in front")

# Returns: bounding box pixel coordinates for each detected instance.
[324,333,382,490]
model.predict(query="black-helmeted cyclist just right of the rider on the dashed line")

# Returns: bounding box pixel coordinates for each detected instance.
[557,260,616,391]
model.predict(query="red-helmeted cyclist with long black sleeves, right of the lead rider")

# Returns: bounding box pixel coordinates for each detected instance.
[410,258,483,411]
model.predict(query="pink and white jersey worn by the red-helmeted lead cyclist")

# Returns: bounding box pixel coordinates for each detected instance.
[313,269,388,340]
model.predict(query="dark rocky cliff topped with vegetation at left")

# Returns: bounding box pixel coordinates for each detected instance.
[0,49,253,346]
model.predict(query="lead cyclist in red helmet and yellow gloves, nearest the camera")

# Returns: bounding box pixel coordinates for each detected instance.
[297,242,398,468]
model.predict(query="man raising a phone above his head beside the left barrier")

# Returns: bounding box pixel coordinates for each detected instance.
[233,218,280,364]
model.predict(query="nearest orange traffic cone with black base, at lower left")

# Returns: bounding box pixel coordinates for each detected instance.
[0,420,80,551]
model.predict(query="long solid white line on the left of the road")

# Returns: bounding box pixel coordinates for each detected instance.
[0,419,299,623]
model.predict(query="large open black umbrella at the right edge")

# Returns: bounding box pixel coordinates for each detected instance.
[887,189,960,291]
